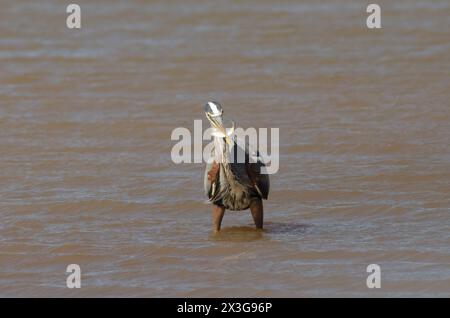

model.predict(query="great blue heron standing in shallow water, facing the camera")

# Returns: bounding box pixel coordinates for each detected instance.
[204,102,270,232]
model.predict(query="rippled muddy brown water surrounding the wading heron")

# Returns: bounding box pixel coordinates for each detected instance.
[0,0,450,297]
